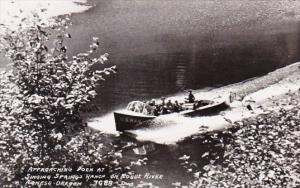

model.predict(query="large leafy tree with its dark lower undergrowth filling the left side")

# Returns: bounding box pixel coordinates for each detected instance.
[0,14,116,187]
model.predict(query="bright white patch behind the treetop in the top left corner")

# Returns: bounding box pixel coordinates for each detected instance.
[0,0,91,29]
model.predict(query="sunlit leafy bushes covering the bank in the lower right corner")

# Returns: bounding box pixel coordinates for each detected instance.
[191,91,300,187]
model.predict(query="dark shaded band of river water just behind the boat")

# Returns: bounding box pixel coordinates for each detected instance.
[92,26,300,113]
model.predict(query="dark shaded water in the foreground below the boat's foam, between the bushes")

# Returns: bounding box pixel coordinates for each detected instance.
[113,131,230,187]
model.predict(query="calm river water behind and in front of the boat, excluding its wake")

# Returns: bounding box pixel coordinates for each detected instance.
[62,0,300,187]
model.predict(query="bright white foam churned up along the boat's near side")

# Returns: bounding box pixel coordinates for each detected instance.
[129,106,263,144]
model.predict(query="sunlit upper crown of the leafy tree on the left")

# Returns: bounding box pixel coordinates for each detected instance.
[3,15,116,134]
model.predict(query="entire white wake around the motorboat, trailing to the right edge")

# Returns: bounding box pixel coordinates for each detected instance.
[89,63,300,144]
